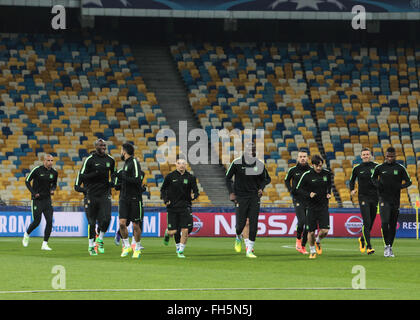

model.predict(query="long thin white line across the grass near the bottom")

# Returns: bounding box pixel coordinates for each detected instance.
[0,287,387,294]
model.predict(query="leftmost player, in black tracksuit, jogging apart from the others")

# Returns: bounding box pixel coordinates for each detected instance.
[22,154,58,251]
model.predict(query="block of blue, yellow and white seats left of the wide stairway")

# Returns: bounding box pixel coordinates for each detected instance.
[0,34,209,205]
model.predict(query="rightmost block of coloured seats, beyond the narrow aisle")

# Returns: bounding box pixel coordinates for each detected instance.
[302,44,420,207]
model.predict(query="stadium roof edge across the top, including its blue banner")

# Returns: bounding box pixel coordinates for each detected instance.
[0,0,420,20]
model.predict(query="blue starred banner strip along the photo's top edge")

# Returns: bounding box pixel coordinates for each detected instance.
[82,0,420,12]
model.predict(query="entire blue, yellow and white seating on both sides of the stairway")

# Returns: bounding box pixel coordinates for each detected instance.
[0,34,420,207]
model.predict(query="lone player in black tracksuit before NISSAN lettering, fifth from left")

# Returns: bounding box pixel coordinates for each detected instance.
[226,143,271,258]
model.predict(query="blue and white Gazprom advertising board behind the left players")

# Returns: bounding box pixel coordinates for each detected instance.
[0,211,160,237]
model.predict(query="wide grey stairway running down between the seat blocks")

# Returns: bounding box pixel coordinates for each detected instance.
[132,45,232,206]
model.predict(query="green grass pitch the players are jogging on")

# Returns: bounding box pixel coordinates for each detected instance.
[0,238,420,300]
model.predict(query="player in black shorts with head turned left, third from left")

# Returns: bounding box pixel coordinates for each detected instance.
[117,143,144,259]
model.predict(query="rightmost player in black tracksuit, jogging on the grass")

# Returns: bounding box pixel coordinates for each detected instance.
[372,147,412,258]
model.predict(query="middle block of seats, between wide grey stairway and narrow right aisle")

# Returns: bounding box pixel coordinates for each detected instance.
[171,43,319,205]
